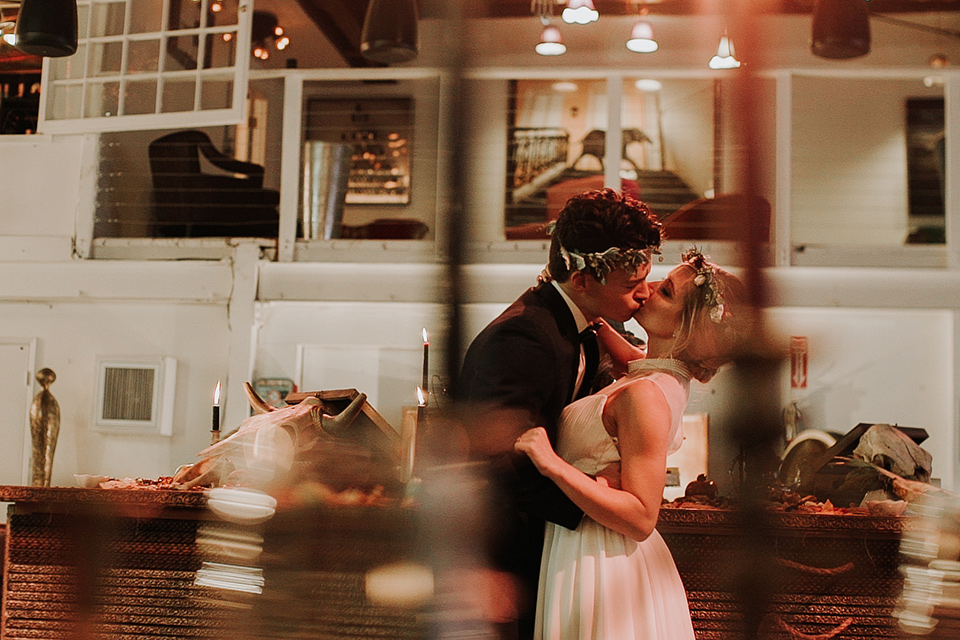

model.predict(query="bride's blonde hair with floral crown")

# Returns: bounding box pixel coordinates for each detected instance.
[671,248,749,382]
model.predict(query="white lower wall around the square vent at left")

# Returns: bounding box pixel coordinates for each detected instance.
[0,300,231,486]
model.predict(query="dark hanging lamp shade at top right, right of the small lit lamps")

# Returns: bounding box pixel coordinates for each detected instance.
[810,0,870,59]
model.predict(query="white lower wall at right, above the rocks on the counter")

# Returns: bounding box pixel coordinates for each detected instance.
[770,308,957,488]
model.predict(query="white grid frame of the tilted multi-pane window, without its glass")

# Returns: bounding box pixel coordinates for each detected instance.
[37,0,253,134]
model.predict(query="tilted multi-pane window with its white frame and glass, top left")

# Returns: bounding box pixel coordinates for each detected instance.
[40,0,252,133]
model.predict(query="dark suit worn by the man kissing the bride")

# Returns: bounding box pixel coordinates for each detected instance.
[457,283,594,632]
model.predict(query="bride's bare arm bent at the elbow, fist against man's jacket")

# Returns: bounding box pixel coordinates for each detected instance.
[515,380,670,541]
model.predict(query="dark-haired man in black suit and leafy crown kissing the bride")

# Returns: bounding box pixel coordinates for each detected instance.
[457,189,661,639]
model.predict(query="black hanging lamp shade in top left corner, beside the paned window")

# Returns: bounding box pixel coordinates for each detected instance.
[16,0,77,58]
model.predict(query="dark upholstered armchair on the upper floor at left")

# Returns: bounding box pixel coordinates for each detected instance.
[148,130,280,238]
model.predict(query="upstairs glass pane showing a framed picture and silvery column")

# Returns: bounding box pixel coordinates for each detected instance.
[299,78,439,240]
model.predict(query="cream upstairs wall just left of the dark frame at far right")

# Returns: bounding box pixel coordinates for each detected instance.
[791,76,943,245]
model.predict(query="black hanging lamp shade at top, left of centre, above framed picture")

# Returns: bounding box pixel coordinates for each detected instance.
[360,0,420,64]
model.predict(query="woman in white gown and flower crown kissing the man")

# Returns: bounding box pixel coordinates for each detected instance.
[515,249,747,640]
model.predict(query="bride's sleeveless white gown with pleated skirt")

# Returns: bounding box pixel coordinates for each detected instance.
[535,371,694,640]
